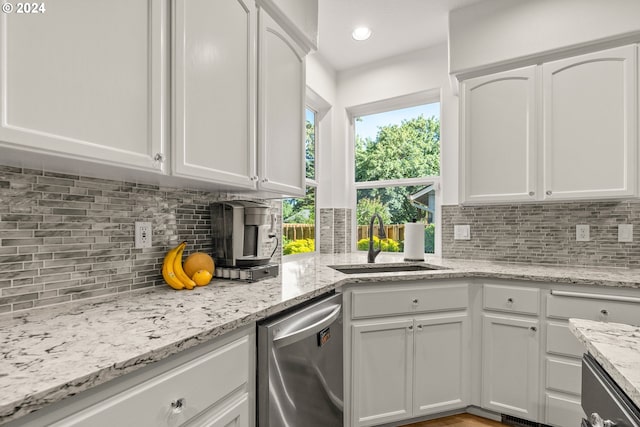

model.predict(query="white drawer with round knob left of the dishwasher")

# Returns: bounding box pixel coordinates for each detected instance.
[52,337,250,427]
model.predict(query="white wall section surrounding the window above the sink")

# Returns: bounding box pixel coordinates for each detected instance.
[332,44,458,207]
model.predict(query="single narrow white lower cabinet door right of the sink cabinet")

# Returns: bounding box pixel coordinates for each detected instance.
[482,314,540,421]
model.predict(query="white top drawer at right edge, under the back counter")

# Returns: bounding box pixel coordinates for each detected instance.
[547,291,640,325]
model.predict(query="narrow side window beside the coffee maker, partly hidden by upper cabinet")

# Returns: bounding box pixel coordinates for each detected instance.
[282,107,318,255]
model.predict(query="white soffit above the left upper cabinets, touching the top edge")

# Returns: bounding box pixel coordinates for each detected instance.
[257,0,318,54]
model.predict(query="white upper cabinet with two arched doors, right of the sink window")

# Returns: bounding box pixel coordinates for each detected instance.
[460,45,638,203]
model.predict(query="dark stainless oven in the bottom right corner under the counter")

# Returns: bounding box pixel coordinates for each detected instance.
[582,353,640,427]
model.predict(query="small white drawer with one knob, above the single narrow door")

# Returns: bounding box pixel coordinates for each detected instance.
[483,285,540,314]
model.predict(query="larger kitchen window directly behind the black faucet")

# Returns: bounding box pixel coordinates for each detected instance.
[349,91,440,253]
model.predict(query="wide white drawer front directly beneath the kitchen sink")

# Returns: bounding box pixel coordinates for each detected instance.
[351,284,469,319]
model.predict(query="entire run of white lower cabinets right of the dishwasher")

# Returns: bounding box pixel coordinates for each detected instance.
[344,279,640,427]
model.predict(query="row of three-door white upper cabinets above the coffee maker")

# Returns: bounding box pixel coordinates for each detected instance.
[0,0,310,197]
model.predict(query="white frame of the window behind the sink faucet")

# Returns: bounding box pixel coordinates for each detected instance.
[346,89,443,256]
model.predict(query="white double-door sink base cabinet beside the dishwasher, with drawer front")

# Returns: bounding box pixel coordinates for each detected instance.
[345,282,469,426]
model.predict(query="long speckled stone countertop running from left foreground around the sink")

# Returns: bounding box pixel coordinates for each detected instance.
[0,253,640,424]
